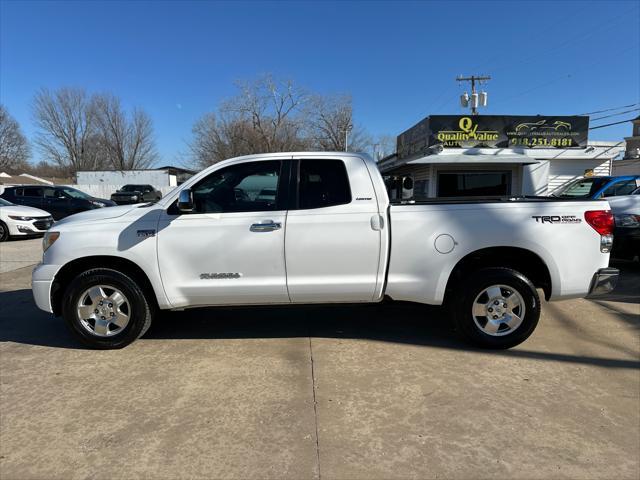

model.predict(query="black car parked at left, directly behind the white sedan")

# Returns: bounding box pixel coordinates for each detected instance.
[0,185,115,220]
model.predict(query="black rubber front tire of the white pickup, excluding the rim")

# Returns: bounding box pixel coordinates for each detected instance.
[62,268,156,350]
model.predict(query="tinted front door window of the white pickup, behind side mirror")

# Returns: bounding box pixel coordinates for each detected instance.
[192,161,282,213]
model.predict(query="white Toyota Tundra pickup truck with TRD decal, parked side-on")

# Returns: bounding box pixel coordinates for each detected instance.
[32,152,618,348]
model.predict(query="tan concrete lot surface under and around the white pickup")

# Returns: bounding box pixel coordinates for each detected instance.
[0,240,640,480]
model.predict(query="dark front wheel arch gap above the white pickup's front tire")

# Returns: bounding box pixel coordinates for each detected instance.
[51,255,158,316]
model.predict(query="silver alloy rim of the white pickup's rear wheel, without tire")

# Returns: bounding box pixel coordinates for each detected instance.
[471,285,526,337]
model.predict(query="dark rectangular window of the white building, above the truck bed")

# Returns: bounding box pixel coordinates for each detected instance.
[438,171,511,197]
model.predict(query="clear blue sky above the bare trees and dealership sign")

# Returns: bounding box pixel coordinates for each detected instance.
[0,0,640,164]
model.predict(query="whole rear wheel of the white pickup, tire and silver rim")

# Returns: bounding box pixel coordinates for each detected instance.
[451,268,540,349]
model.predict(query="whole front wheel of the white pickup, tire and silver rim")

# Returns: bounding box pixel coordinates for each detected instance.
[62,268,154,350]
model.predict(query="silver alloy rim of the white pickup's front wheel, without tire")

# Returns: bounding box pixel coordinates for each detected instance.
[77,285,131,337]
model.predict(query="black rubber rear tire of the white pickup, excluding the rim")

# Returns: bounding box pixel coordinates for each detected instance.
[448,268,540,349]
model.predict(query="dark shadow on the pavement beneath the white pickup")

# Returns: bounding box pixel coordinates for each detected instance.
[0,289,640,369]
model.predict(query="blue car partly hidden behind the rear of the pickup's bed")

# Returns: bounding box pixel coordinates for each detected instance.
[551,175,640,199]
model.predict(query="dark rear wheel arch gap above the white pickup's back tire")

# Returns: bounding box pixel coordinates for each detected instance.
[445,247,552,302]
